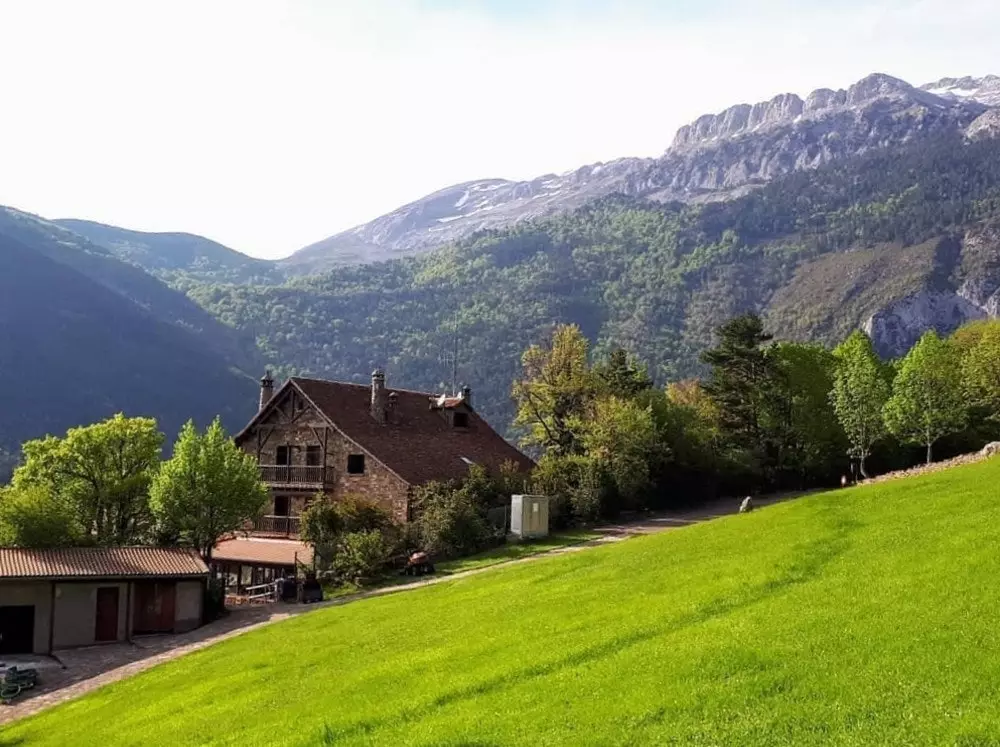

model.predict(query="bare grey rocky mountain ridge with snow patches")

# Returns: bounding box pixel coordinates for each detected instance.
[288,73,1000,274]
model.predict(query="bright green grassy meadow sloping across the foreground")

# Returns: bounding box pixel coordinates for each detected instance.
[7,459,1000,747]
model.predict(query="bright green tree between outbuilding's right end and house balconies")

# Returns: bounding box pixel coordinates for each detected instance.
[150,418,268,560]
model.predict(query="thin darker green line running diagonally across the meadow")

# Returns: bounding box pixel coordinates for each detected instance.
[321,505,862,745]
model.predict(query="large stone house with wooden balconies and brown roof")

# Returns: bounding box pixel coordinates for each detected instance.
[213,370,534,582]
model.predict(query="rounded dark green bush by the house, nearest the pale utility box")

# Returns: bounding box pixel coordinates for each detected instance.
[416,483,494,557]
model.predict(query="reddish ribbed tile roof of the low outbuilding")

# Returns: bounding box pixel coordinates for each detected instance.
[0,547,208,578]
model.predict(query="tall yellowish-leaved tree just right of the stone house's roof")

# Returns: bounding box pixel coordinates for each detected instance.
[512,324,595,454]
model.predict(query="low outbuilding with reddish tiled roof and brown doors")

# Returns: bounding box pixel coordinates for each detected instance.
[0,547,208,655]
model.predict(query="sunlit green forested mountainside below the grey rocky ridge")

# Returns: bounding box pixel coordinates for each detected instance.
[184,133,1000,427]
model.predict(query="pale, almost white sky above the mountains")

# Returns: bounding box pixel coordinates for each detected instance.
[0,0,1000,258]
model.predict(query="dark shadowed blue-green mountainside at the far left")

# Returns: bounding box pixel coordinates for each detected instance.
[0,218,255,450]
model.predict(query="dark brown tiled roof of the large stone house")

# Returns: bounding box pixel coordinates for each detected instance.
[290,377,534,485]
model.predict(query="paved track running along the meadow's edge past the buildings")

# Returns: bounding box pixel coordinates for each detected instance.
[0,494,784,724]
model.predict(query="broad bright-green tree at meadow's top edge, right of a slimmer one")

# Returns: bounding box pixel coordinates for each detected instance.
[884,330,968,464]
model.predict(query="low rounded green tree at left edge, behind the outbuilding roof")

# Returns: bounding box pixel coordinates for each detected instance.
[0,485,86,547]
